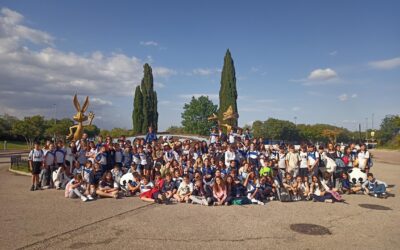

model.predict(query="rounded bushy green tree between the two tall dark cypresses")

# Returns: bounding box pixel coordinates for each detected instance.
[182,96,217,135]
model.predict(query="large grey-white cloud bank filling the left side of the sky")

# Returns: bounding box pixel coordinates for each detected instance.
[0,8,176,129]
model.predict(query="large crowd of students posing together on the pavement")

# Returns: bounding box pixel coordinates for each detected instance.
[29,128,387,205]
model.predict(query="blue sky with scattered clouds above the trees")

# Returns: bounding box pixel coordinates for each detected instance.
[0,0,400,130]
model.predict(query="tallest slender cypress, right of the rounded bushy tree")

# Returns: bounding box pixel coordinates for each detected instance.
[219,49,238,127]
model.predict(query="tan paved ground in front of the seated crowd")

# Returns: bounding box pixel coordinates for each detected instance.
[0,150,400,249]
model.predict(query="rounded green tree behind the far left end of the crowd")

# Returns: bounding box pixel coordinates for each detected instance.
[12,115,46,147]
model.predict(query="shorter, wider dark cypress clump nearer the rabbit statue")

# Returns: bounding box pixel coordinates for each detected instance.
[132,63,158,134]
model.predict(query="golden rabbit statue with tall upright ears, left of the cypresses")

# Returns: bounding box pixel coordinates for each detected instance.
[67,94,94,141]
